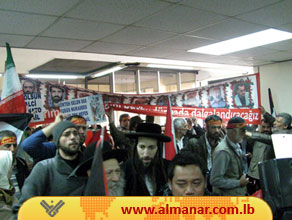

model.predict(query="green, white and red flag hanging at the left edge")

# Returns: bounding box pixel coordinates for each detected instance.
[0,43,26,114]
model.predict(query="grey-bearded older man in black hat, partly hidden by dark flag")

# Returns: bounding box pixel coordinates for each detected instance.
[79,141,128,196]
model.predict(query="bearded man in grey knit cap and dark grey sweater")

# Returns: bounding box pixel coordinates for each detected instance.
[14,121,88,215]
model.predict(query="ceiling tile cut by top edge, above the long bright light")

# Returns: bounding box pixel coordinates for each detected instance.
[181,0,281,16]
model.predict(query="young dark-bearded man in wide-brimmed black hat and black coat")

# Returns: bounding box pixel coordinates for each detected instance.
[125,123,171,196]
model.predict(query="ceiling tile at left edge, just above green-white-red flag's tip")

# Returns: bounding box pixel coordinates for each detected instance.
[0,34,33,47]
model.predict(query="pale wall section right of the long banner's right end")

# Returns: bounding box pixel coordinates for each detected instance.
[259,61,292,114]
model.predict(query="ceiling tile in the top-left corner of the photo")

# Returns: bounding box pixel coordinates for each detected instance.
[0,0,78,16]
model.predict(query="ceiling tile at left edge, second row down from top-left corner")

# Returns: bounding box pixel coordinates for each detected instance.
[0,11,56,35]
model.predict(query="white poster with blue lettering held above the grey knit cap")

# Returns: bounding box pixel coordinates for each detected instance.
[59,94,106,125]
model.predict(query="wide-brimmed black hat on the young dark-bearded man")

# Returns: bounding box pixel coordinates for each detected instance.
[126,123,171,142]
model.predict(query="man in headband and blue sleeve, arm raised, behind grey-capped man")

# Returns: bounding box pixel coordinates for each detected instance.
[21,113,87,163]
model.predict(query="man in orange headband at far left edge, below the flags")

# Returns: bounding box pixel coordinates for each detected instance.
[0,130,29,199]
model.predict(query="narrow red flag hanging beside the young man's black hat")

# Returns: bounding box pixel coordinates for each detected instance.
[163,97,177,160]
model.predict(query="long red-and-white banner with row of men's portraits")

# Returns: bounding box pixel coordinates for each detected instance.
[20,74,261,124]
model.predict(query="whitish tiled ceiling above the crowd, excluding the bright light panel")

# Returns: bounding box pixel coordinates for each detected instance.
[0,0,292,77]
